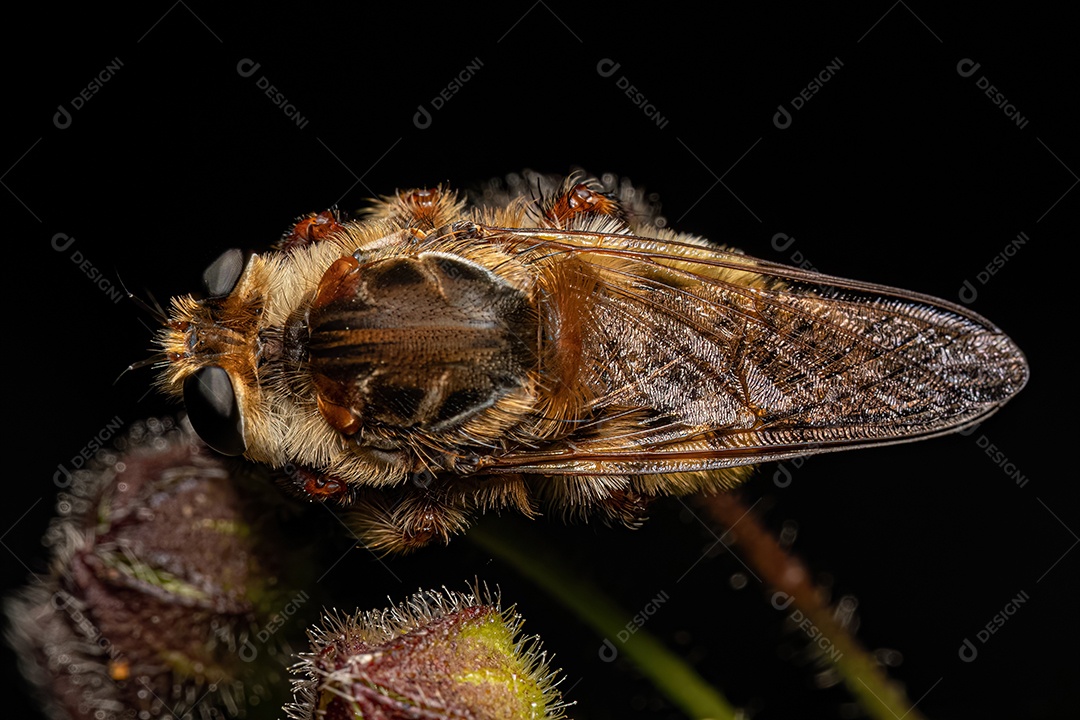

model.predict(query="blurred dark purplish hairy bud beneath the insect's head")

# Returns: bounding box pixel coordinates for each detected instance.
[5,420,315,720]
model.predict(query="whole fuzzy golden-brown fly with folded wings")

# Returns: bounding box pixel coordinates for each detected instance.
[158,176,1028,551]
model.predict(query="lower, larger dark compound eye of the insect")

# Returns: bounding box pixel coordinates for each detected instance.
[184,365,247,456]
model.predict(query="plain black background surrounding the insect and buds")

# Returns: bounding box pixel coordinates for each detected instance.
[0,1,1080,718]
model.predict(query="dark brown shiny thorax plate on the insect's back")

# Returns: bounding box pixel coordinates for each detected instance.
[302,253,537,435]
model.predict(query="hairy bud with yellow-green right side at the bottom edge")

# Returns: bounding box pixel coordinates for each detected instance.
[285,587,566,720]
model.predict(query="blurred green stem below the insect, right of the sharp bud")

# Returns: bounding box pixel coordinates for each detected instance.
[467,524,741,720]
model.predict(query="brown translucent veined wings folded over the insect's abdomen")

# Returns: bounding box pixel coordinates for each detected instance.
[481,228,1028,475]
